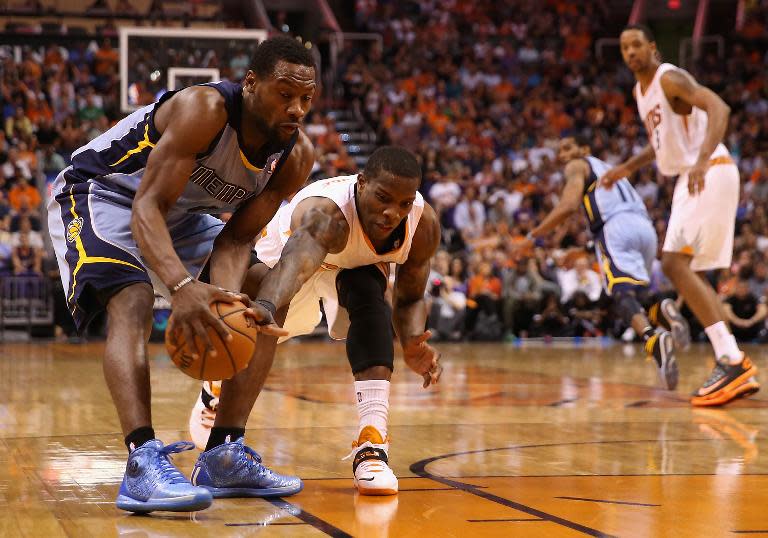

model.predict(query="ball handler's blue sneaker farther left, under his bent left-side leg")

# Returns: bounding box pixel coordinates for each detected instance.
[115,439,213,513]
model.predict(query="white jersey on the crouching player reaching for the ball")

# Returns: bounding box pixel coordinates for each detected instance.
[256,175,424,269]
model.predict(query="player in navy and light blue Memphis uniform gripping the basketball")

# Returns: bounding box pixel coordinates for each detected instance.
[48,37,316,512]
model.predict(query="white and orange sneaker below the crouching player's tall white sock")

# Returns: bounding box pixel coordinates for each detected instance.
[344,426,397,495]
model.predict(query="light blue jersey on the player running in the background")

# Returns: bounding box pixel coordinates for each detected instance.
[582,156,648,233]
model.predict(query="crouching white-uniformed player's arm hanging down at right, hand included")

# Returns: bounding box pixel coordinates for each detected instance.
[392,204,443,388]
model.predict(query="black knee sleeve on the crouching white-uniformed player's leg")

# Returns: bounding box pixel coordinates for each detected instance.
[337,266,395,374]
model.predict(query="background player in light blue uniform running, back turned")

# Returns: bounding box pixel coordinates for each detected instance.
[515,135,689,390]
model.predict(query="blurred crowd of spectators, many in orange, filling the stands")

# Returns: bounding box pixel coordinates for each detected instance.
[0,0,768,340]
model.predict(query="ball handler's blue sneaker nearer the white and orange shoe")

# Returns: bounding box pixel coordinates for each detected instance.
[192,437,304,498]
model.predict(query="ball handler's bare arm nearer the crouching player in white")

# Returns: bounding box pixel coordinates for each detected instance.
[211,131,314,298]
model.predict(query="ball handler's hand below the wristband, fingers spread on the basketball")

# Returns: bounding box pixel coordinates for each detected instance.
[170,280,238,358]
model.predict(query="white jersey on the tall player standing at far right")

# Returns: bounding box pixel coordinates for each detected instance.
[635,63,728,176]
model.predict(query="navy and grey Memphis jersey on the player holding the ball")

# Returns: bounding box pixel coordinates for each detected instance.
[68,80,298,219]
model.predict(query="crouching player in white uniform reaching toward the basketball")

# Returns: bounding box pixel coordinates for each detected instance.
[190,146,442,495]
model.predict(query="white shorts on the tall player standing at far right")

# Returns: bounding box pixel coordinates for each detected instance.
[662,157,740,271]
